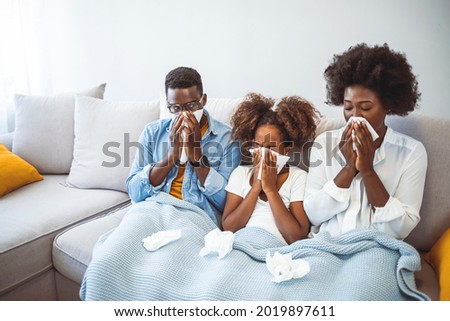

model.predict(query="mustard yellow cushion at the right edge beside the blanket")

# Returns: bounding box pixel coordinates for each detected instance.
[425,228,450,301]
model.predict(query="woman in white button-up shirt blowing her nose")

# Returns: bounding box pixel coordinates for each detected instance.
[304,44,427,239]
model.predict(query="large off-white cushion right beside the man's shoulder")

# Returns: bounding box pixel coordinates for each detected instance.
[67,96,159,192]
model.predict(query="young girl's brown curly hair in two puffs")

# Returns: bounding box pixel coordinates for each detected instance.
[231,93,319,161]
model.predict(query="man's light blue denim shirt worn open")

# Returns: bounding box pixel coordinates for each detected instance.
[126,109,241,224]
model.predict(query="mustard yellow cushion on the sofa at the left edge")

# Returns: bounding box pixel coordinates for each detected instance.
[0,144,44,197]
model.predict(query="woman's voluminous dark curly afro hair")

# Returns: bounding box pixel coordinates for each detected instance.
[324,43,421,116]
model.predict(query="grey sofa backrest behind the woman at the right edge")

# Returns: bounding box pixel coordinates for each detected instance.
[386,113,450,252]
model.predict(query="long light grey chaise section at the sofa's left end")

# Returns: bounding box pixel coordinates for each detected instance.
[0,175,129,295]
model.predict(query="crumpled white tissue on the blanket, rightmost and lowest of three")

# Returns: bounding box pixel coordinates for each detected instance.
[266,252,310,283]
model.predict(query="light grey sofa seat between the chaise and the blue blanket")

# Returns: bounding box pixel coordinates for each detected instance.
[53,206,129,284]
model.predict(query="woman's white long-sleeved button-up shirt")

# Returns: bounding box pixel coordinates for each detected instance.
[303,128,427,239]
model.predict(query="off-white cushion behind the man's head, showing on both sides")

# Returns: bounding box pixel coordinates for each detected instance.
[160,94,242,125]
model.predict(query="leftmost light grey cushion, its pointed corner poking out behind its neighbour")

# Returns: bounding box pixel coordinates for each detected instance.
[12,84,106,174]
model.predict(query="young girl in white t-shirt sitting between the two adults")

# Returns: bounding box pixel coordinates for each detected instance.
[222,93,317,244]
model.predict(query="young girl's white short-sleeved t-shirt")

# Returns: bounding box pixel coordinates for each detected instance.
[225,166,307,242]
